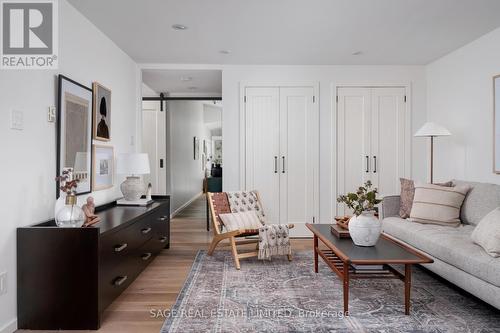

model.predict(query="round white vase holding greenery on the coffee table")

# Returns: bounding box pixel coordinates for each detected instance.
[349,211,382,246]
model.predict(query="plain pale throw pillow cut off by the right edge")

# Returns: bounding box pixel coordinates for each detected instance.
[471,207,500,258]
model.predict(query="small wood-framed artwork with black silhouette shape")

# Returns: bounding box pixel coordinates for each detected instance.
[92,82,111,141]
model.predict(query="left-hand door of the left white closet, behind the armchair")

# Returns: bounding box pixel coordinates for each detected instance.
[245,88,280,223]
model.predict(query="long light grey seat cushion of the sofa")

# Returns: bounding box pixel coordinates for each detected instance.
[382,217,500,287]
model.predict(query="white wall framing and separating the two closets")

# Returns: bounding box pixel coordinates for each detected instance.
[222,66,426,222]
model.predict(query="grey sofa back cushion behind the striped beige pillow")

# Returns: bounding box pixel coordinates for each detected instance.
[453,180,500,225]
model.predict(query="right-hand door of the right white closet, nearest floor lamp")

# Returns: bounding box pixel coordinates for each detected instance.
[371,88,408,196]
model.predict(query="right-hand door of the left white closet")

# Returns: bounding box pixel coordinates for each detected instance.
[279,87,319,236]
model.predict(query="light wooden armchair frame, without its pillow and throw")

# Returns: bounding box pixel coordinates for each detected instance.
[207,192,294,269]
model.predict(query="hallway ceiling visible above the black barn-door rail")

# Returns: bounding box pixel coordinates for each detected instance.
[142,69,222,97]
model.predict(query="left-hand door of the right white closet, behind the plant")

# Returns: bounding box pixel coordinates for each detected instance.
[337,88,371,215]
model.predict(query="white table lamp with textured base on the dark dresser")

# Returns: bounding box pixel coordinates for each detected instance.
[116,153,150,205]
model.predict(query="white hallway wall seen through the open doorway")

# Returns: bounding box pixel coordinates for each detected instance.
[167,101,210,213]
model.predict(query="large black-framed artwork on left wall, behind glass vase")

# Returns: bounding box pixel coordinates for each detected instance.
[56,75,92,198]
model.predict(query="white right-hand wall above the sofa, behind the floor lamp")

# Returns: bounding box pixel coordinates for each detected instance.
[427,29,500,183]
